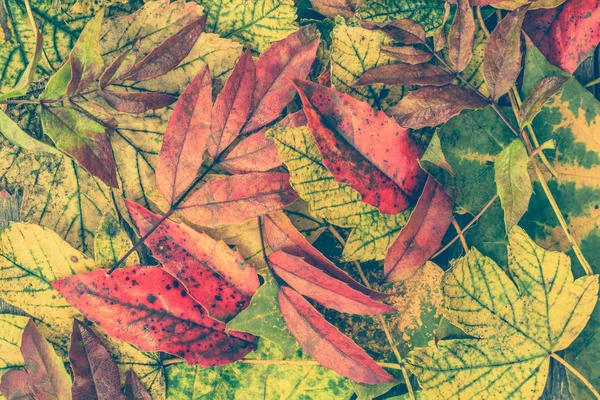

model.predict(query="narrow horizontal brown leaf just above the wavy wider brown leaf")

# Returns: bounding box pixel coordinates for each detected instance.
[355,64,455,86]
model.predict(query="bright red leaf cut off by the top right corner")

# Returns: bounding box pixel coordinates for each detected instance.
[523,0,600,74]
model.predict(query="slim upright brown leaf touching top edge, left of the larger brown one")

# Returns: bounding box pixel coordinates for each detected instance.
[448,0,475,72]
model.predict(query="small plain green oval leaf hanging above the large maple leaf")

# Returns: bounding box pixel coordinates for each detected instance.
[494,139,533,232]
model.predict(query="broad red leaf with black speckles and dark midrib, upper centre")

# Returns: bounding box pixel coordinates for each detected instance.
[296,81,424,214]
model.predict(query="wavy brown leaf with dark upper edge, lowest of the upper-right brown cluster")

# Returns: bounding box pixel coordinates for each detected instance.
[387,84,489,129]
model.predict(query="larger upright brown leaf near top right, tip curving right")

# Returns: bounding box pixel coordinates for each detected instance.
[483,4,529,100]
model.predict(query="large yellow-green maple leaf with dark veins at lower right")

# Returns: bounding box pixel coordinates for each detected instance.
[407,227,598,399]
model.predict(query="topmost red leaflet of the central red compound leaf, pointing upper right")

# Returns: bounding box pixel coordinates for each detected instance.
[243,25,319,133]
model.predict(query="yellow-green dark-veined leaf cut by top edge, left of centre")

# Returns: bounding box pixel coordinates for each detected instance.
[198,0,298,53]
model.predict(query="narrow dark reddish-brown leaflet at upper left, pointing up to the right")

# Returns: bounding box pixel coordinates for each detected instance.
[123,15,207,81]
